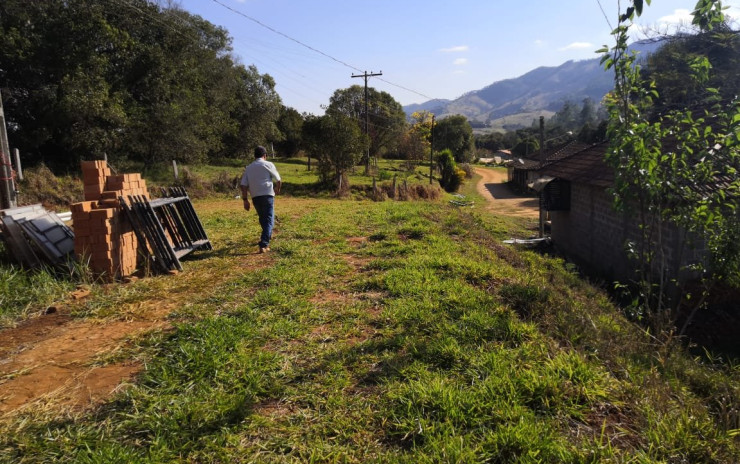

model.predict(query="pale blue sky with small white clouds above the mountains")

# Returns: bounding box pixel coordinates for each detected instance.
[175,0,740,115]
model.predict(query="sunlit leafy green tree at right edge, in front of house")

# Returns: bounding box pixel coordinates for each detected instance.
[602,0,740,330]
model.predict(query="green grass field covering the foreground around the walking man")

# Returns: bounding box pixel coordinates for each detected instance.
[0,159,740,463]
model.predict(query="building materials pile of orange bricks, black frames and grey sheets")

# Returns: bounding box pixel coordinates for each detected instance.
[0,161,212,280]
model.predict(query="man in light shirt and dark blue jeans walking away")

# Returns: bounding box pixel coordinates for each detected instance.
[239,146,282,253]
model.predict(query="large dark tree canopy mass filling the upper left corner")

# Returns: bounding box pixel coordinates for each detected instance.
[0,0,280,169]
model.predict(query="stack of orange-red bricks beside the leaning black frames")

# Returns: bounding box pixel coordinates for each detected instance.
[71,161,149,279]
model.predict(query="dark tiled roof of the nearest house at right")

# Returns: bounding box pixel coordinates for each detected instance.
[540,142,614,188]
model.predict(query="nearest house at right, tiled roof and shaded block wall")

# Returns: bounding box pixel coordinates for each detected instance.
[538,143,701,281]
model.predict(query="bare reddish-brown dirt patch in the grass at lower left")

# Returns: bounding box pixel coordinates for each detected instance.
[0,298,171,417]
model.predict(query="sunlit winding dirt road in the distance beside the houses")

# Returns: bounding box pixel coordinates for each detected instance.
[475,168,539,217]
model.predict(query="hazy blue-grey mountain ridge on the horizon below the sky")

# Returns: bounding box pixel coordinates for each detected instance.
[404,42,660,128]
